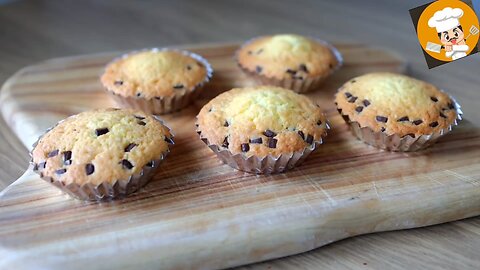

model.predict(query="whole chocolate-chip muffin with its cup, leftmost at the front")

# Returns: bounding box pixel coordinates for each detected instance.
[30,109,173,200]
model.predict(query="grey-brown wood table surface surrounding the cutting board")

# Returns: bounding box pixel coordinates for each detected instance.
[0,0,480,269]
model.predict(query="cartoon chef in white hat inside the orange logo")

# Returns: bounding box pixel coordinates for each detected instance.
[428,7,469,60]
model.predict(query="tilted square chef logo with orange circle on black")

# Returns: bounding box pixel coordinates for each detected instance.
[410,0,480,68]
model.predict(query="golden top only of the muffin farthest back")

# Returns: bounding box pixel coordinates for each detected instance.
[236,35,339,79]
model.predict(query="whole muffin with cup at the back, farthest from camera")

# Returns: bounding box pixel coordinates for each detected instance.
[236,35,342,92]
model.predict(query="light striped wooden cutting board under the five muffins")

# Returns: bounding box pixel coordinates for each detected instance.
[0,44,480,269]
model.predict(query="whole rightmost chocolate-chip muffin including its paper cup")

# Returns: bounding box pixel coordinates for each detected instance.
[335,73,462,151]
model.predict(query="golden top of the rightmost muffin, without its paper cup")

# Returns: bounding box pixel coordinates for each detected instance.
[335,72,457,137]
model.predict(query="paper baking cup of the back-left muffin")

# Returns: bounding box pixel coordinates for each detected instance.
[106,48,213,114]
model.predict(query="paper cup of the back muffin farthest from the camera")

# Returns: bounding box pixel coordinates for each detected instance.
[235,37,343,93]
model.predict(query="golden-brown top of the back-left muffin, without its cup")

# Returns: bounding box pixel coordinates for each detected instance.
[101,49,212,99]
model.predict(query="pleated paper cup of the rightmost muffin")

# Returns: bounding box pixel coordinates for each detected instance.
[338,97,463,152]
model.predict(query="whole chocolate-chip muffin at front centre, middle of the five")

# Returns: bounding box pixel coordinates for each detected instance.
[197,86,328,174]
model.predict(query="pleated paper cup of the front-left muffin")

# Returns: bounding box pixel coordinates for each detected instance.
[30,116,173,201]
